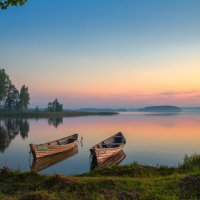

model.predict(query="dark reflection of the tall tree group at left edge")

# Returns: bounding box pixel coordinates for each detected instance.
[0,118,30,152]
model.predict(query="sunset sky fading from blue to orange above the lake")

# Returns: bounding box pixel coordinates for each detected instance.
[0,0,200,109]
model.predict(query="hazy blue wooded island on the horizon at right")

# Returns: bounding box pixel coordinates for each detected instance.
[137,105,182,112]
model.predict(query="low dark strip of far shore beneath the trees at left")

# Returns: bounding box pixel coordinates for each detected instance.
[0,111,118,118]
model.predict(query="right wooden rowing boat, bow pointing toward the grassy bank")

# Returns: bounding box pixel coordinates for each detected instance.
[90,132,126,164]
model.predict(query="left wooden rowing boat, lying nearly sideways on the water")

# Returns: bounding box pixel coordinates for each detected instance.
[30,134,78,158]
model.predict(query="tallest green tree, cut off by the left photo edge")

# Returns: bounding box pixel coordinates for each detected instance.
[0,69,11,106]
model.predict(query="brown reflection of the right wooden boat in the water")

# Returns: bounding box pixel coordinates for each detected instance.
[91,150,126,170]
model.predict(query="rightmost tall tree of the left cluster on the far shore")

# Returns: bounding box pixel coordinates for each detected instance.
[18,85,30,110]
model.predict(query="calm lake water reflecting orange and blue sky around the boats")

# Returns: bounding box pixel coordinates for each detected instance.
[0,113,200,175]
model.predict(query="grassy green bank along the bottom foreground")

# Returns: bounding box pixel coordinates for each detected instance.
[0,154,200,200]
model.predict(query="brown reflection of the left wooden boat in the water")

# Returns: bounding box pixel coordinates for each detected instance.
[31,145,78,172]
